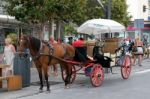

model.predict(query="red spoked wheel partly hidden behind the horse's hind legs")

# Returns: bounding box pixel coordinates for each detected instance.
[61,65,76,83]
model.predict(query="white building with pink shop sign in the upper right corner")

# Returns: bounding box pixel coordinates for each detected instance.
[127,0,150,43]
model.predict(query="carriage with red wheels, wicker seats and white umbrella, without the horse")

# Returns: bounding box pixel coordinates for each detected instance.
[62,18,132,87]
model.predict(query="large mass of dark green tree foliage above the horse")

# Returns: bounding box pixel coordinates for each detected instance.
[5,0,86,23]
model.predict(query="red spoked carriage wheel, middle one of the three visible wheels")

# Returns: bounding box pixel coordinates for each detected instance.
[90,64,104,87]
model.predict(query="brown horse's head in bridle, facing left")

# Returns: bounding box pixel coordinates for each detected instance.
[18,35,29,54]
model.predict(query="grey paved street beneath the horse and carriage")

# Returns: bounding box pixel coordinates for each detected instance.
[0,59,150,99]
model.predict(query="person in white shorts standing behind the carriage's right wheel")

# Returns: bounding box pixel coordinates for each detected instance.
[133,37,144,66]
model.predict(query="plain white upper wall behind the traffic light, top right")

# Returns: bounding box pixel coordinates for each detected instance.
[127,0,148,21]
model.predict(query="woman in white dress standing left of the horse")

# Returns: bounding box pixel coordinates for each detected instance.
[3,38,16,76]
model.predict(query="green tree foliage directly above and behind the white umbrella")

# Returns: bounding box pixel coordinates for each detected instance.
[69,0,131,26]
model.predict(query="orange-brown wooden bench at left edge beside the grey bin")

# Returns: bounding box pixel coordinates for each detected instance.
[0,75,22,91]
